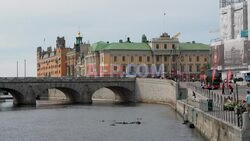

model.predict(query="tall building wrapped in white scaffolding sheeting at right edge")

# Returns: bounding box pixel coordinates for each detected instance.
[211,0,250,78]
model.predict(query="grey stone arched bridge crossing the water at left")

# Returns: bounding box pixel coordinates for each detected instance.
[0,77,136,105]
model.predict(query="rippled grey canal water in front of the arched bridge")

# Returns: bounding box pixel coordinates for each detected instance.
[0,101,205,141]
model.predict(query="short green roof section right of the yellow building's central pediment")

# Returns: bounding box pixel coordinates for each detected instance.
[180,43,210,51]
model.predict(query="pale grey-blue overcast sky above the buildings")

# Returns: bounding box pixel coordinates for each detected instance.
[0,0,219,77]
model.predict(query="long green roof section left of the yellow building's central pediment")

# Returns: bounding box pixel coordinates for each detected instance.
[91,42,151,51]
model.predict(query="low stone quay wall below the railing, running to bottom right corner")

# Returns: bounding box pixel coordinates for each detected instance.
[176,100,250,141]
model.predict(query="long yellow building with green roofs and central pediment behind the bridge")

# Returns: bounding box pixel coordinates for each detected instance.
[85,33,210,80]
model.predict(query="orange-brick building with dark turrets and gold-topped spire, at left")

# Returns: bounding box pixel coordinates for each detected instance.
[37,32,90,77]
